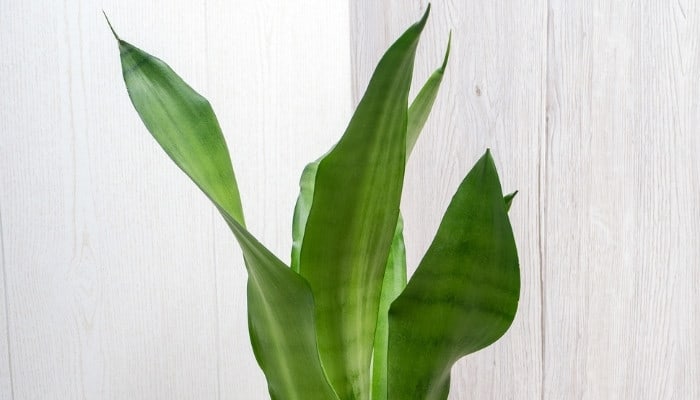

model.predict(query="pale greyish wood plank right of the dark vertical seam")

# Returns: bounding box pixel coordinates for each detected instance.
[543,0,700,399]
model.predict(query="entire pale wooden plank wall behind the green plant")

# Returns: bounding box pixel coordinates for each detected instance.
[0,0,700,400]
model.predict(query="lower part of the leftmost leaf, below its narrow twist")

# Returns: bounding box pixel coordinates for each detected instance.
[222,212,338,400]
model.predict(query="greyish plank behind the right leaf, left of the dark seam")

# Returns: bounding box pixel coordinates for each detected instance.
[351,0,546,399]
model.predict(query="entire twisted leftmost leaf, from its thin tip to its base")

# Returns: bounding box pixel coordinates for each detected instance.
[110,22,337,400]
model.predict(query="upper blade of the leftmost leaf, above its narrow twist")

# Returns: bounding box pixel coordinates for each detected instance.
[119,36,243,223]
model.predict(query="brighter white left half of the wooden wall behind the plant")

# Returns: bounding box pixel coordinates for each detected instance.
[0,1,351,399]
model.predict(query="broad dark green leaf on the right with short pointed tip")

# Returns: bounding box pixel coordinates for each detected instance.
[389,151,520,400]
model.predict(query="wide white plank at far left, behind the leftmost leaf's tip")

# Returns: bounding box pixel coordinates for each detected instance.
[0,1,217,399]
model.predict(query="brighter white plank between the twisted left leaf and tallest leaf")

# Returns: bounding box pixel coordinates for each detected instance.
[206,0,351,400]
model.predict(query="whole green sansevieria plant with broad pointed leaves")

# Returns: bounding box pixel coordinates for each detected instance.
[105,7,520,400]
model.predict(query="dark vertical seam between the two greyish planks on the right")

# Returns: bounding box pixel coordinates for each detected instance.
[537,0,551,400]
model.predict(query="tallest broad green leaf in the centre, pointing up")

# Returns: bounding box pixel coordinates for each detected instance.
[299,7,428,400]
